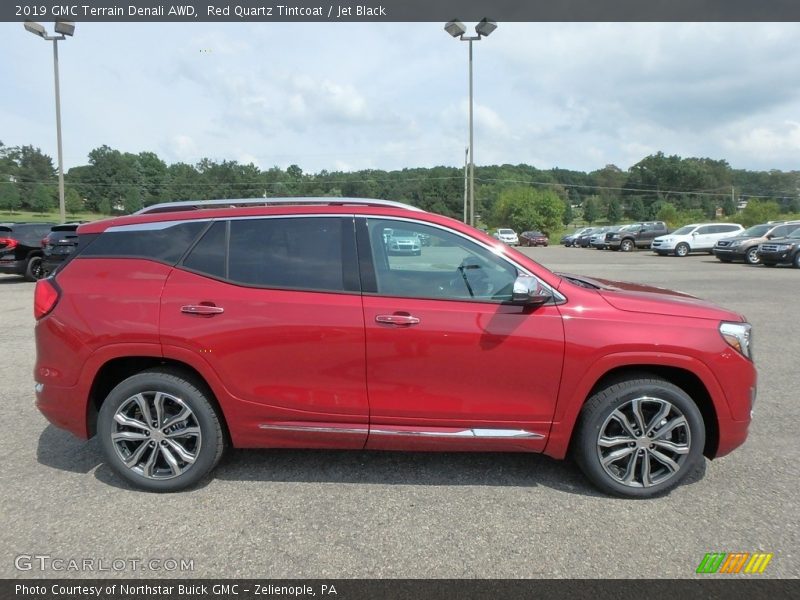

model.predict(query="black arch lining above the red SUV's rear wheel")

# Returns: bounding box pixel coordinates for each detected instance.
[86,356,231,445]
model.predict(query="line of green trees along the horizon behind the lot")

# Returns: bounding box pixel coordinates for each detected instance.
[0,142,800,233]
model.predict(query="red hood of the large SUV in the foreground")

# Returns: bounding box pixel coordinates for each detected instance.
[559,273,745,321]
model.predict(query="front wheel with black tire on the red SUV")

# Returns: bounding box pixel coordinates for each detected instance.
[572,374,705,498]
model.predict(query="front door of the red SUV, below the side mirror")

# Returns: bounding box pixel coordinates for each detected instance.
[357,219,564,450]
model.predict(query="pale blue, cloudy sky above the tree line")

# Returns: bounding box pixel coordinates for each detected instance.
[0,22,800,172]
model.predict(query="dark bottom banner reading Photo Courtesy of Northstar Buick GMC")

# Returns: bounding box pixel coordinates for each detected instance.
[0,575,800,600]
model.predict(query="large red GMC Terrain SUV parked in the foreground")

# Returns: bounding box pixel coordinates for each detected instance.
[34,198,756,497]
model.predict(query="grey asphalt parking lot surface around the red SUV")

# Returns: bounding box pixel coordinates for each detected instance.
[0,246,800,578]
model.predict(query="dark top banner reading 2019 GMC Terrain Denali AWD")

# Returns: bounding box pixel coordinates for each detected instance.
[0,0,800,22]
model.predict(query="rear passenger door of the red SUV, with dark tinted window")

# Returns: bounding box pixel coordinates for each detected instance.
[160,217,368,448]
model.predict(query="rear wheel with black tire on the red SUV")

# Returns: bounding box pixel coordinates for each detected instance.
[97,369,225,492]
